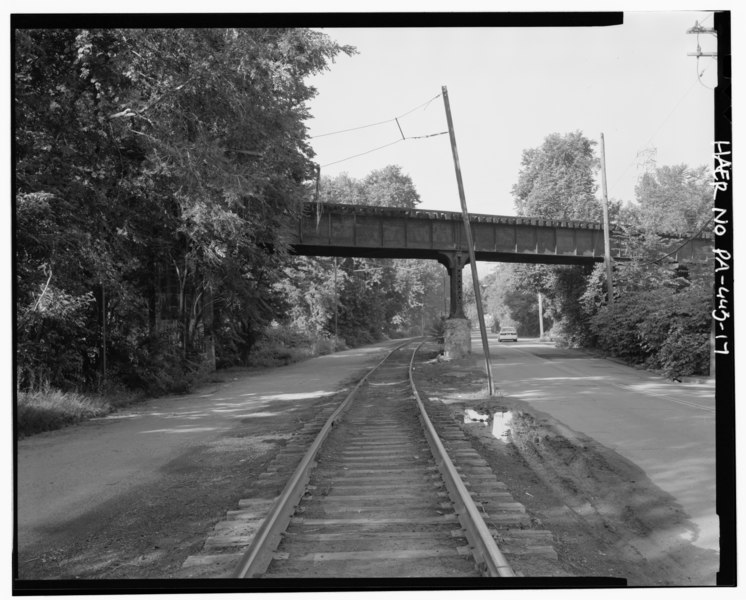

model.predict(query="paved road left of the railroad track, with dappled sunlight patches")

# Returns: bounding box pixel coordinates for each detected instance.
[16,342,396,551]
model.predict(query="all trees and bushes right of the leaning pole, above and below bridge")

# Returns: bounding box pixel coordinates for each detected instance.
[467,132,713,378]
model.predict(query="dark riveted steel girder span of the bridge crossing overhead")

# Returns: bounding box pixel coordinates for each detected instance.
[291,203,712,264]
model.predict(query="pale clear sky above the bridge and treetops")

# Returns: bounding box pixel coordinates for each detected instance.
[308,10,717,215]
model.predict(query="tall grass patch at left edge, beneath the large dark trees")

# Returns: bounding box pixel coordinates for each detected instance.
[16,389,142,439]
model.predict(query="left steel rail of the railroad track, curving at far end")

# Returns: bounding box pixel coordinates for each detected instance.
[232,339,412,579]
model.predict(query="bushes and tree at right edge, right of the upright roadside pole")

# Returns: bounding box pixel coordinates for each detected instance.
[580,159,713,378]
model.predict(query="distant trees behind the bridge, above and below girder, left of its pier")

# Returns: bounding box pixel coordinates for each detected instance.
[278,165,447,346]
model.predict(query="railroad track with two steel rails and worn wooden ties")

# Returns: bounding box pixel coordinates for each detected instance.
[224,342,514,578]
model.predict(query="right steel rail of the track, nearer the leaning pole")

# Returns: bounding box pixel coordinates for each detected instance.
[409,342,516,577]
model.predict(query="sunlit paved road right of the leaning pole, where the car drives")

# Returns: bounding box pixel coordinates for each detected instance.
[472,334,719,550]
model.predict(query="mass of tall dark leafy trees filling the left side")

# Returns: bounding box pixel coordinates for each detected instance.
[14,29,352,391]
